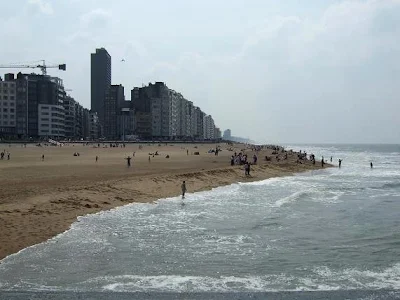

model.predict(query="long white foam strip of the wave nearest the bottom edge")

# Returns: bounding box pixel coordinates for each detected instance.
[94,264,400,292]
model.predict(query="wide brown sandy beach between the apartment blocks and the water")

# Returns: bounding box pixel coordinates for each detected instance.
[0,143,321,259]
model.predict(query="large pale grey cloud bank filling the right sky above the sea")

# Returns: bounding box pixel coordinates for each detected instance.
[146,0,400,142]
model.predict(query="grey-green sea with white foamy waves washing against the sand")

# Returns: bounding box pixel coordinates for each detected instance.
[0,145,400,300]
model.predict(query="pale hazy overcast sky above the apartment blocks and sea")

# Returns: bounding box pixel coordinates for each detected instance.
[0,0,400,143]
